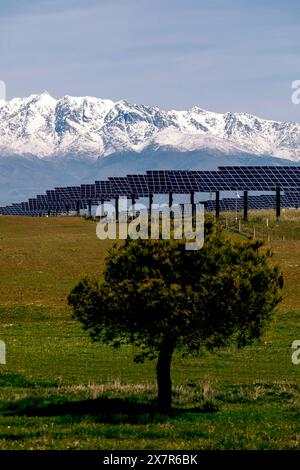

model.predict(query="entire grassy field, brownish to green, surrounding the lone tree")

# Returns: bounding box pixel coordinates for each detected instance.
[0,211,300,450]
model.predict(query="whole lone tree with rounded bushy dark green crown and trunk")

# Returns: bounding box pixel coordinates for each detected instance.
[68,223,282,412]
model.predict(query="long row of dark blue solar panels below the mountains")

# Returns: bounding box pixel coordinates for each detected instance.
[0,166,300,215]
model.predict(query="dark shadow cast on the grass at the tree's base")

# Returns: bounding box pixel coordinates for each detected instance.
[0,397,217,424]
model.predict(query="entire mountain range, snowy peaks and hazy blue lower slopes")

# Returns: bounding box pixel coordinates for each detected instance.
[0,92,300,204]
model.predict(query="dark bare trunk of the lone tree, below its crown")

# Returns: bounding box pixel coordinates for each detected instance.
[156,340,174,413]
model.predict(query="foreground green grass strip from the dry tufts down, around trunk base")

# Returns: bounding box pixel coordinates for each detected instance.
[0,383,300,449]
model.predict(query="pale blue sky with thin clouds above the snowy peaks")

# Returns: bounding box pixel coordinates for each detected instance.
[0,0,300,121]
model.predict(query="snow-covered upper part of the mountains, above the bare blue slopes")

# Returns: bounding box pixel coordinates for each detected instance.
[0,92,300,161]
